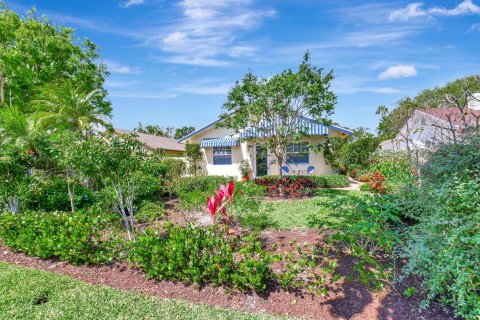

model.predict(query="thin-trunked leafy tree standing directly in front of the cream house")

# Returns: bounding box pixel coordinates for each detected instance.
[221,52,337,176]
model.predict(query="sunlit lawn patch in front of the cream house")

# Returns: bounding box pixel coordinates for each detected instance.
[244,189,367,230]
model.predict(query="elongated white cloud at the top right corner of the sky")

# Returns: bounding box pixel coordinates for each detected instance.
[388,0,480,21]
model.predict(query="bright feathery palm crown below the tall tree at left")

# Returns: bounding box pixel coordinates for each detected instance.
[32,80,110,136]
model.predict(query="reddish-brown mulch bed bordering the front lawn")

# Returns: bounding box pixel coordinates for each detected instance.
[0,230,453,320]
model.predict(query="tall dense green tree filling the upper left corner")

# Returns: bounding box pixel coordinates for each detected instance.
[0,3,111,114]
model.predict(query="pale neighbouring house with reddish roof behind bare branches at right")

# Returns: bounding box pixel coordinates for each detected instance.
[380,107,480,152]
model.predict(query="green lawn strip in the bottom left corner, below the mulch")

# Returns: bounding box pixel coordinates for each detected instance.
[0,263,284,320]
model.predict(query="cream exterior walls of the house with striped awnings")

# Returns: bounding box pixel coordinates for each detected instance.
[185,127,347,179]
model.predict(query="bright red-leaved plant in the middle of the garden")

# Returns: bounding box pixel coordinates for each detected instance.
[201,180,242,225]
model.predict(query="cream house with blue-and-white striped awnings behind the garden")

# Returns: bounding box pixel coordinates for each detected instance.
[178,117,353,179]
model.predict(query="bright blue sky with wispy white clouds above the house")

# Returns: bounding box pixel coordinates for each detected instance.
[7,0,480,131]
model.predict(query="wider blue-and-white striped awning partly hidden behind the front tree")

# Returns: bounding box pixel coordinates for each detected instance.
[240,117,328,139]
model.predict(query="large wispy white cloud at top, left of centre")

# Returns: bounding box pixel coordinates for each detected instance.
[145,0,276,66]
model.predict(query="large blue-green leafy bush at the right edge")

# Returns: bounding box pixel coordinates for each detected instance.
[401,137,480,319]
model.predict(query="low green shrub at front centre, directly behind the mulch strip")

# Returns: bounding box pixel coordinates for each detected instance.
[130,226,273,291]
